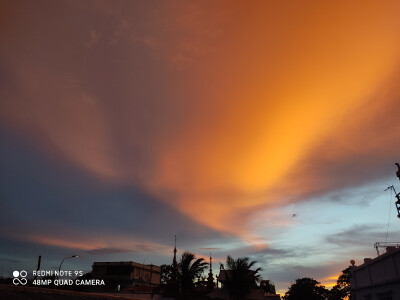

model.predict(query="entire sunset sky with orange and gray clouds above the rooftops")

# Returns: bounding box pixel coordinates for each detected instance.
[0,0,400,293]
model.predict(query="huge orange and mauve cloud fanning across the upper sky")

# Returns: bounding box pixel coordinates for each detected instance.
[1,1,400,241]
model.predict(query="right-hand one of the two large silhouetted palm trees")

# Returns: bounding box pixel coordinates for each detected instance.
[221,255,262,299]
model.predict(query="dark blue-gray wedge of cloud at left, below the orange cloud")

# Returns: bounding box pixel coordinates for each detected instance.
[0,128,225,251]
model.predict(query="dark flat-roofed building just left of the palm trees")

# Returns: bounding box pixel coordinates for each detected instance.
[92,261,161,288]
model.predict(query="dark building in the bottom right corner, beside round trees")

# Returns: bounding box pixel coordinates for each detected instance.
[350,247,400,300]
